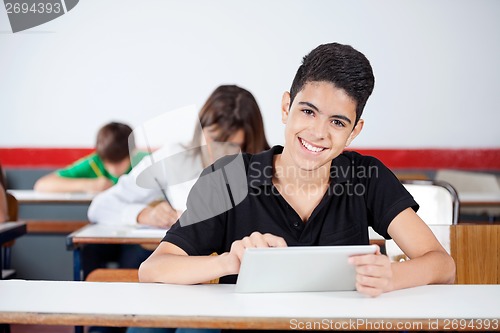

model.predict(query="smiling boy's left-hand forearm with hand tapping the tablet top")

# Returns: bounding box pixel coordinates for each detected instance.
[139,232,286,284]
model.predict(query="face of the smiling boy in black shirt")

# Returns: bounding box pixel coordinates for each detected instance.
[281,82,363,170]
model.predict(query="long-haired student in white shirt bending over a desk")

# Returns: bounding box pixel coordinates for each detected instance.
[88,85,269,333]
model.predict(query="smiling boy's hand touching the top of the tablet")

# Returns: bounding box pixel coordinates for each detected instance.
[228,231,287,274]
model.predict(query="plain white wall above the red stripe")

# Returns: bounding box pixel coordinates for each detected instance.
[0,0,500,148]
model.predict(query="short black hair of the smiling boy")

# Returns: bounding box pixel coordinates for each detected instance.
[290,43,375,123]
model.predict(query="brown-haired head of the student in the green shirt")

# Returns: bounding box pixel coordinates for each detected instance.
[96,122,135,163]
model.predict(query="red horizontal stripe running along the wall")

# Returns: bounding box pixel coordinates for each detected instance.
[0,148,500,171]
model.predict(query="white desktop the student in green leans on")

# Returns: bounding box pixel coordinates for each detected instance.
[7,189,96,203]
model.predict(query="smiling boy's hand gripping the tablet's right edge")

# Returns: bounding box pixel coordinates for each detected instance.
[349,246,393,297]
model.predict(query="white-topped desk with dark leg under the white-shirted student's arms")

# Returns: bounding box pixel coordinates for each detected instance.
[66,224,166,281]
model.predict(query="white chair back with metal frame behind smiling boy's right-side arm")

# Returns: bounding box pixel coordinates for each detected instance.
[386,180,459,261]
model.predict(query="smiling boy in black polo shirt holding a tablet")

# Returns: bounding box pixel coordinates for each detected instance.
[139,43,455,296]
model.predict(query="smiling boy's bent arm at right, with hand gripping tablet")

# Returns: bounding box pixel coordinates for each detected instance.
[351,208,455,296]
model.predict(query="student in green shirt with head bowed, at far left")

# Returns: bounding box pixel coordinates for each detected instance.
[34,122,144,192]
